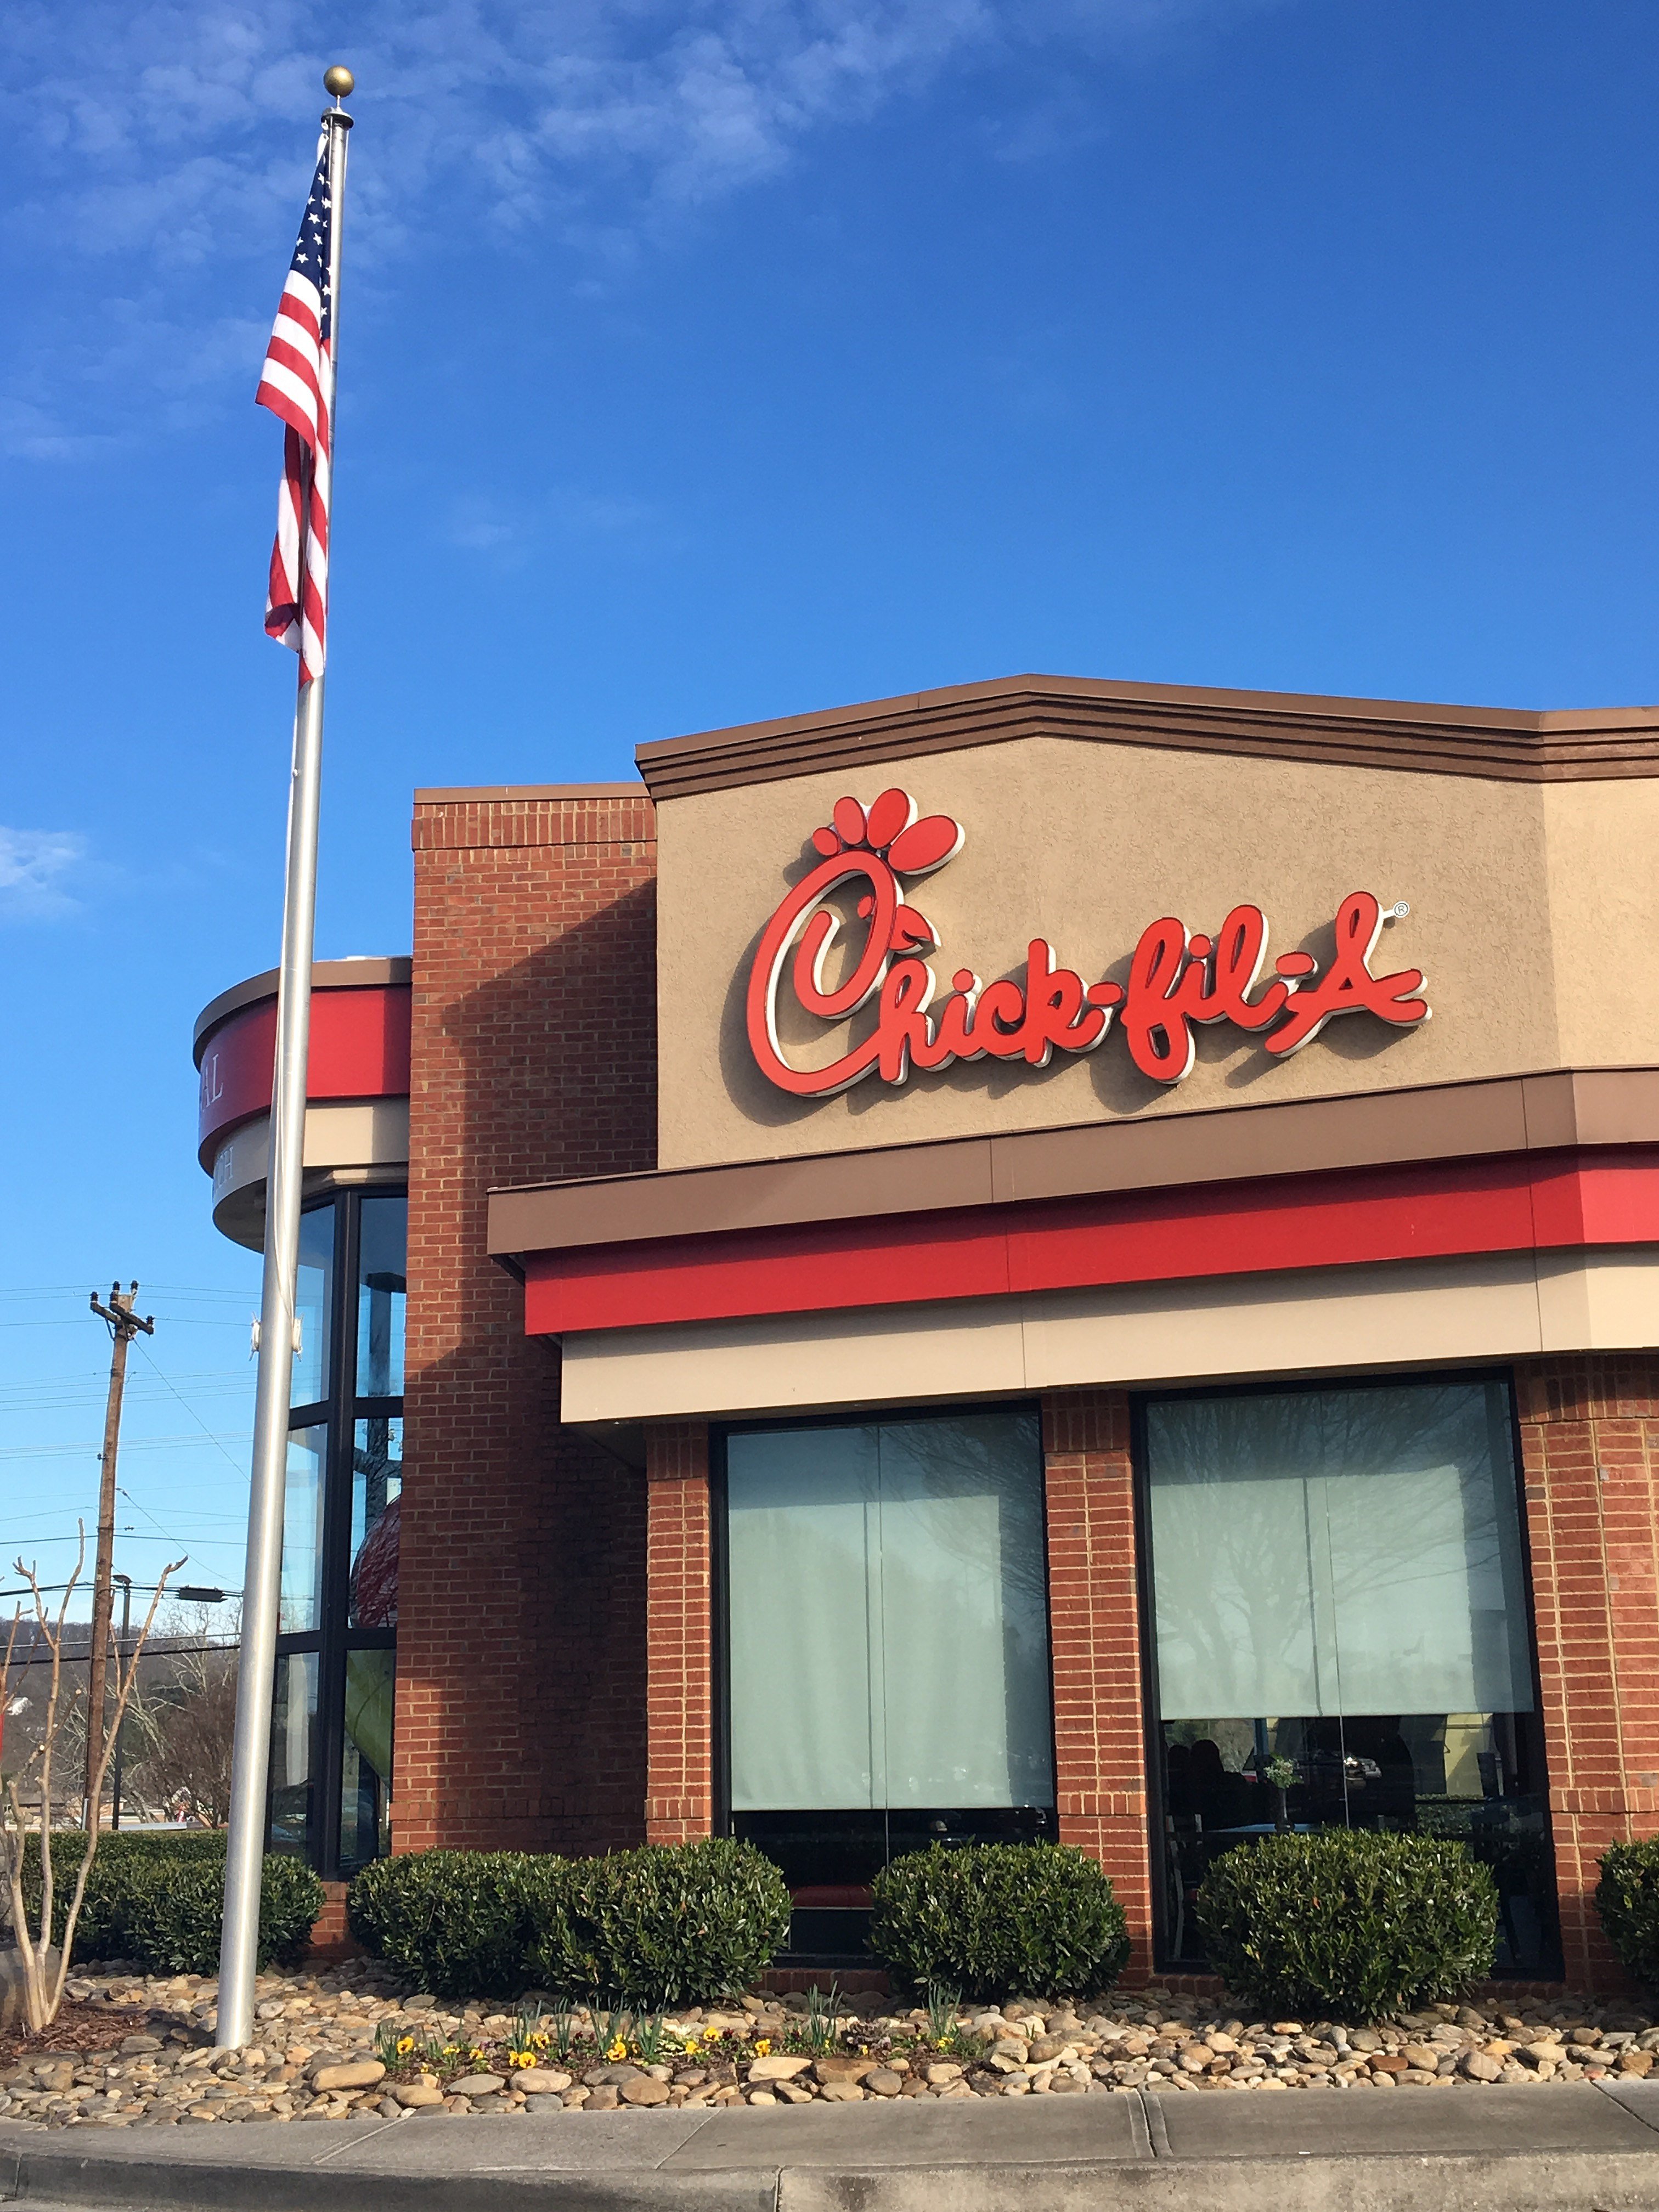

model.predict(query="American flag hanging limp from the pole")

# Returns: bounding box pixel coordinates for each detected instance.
[255,131,334,684]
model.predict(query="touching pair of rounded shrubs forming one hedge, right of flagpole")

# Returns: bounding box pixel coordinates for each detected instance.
[347,1838,789,2008]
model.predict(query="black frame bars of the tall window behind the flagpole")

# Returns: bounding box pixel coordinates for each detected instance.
[266,1183,407,1882]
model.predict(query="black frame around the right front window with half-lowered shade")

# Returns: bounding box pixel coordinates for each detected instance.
[1128,1365,1564,1982]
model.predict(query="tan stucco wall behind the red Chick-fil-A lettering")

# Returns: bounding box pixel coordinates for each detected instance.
[657,737,1659,1168]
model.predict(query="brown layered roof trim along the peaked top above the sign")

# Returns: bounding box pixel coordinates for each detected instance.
[635,675,1659,801]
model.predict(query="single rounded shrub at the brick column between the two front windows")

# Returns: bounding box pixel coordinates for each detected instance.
[870,1843,1128,1997]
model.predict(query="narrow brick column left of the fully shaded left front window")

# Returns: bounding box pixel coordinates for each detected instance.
[646,1420,714,1843]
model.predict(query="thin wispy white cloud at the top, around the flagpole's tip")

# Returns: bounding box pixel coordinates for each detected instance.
[0,0,1283,460]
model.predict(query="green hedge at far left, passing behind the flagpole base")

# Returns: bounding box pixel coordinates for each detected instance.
[22,1829,325,1973]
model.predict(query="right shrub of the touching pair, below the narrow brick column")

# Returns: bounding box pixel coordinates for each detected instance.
[531,1836,789,2011]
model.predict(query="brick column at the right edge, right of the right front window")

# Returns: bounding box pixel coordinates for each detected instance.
[1515,1354,1659,1995]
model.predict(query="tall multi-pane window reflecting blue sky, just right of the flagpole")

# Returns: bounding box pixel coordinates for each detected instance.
[270,1190,409,1876]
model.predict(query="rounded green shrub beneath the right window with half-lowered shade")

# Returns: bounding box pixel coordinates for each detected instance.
[1194,1827,1498,2019]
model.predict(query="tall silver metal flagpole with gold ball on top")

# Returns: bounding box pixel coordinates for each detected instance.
[215,69,352,2051]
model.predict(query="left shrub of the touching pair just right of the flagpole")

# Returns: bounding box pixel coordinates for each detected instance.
[345,1852,564,1997]
